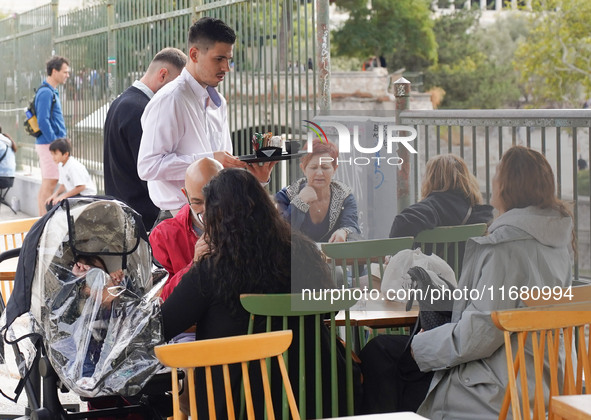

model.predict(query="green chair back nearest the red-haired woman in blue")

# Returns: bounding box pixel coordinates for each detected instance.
[321,236,413,289]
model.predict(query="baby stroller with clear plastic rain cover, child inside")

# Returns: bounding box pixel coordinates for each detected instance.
[0,198,171,419]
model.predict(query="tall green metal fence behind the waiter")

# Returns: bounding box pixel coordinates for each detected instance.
[0,0,330,192]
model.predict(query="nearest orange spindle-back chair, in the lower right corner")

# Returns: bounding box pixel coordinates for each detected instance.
[491,301,591,420]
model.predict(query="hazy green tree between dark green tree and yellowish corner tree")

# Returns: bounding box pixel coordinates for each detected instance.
[424,11,523,109]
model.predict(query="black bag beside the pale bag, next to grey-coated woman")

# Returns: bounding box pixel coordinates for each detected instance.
[406,267,455,331]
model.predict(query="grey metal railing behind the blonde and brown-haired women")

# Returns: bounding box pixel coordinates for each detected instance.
[400,109,591,278]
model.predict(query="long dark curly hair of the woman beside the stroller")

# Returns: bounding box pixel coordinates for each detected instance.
[197,169,291,307]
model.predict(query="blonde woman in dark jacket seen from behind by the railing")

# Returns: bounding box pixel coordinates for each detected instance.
[390,154,493,238]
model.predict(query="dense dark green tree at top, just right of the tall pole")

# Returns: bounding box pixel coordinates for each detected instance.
[332,0,437,70]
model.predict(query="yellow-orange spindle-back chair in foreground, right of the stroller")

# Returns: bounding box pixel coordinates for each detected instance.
[154,330,300,420]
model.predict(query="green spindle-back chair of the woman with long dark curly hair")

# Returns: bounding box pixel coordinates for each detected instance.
[240,293,355,419]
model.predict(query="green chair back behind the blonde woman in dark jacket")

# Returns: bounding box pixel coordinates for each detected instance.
[415,223,487,280]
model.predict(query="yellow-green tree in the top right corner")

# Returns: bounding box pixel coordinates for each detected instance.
[514,0,591,107]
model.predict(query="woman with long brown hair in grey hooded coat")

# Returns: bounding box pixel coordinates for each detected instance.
[412,146,573,420]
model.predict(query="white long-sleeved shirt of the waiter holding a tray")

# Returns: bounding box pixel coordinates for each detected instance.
[137,69,232,210]
